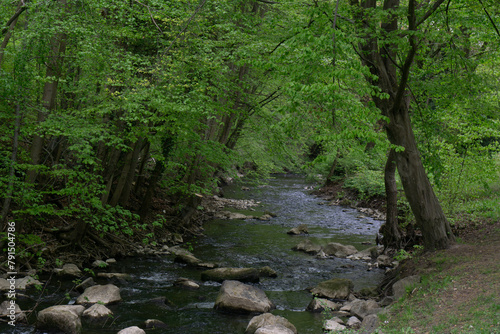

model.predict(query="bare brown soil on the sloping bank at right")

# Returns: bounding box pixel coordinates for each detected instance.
[386,221,500,334]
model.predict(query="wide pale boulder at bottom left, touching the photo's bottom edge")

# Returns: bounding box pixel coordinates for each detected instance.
[36,305,85,334]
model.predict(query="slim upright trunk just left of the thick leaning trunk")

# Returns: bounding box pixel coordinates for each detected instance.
[382,149,402,249]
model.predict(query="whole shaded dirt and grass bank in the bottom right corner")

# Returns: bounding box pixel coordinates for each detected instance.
[382,221,500,334]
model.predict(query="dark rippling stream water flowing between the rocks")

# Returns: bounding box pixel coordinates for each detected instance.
[0,175,383,334]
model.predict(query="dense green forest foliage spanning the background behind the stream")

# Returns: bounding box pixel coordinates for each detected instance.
[0,0,500,256]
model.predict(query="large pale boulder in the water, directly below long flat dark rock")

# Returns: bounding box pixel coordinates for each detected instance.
[214,281,275,313]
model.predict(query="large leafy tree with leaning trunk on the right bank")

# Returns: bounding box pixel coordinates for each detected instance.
[273,1,498,249]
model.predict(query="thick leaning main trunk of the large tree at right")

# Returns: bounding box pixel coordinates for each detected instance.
[351,0,454,250]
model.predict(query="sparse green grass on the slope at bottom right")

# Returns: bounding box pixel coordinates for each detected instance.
[380,253,500,334]
